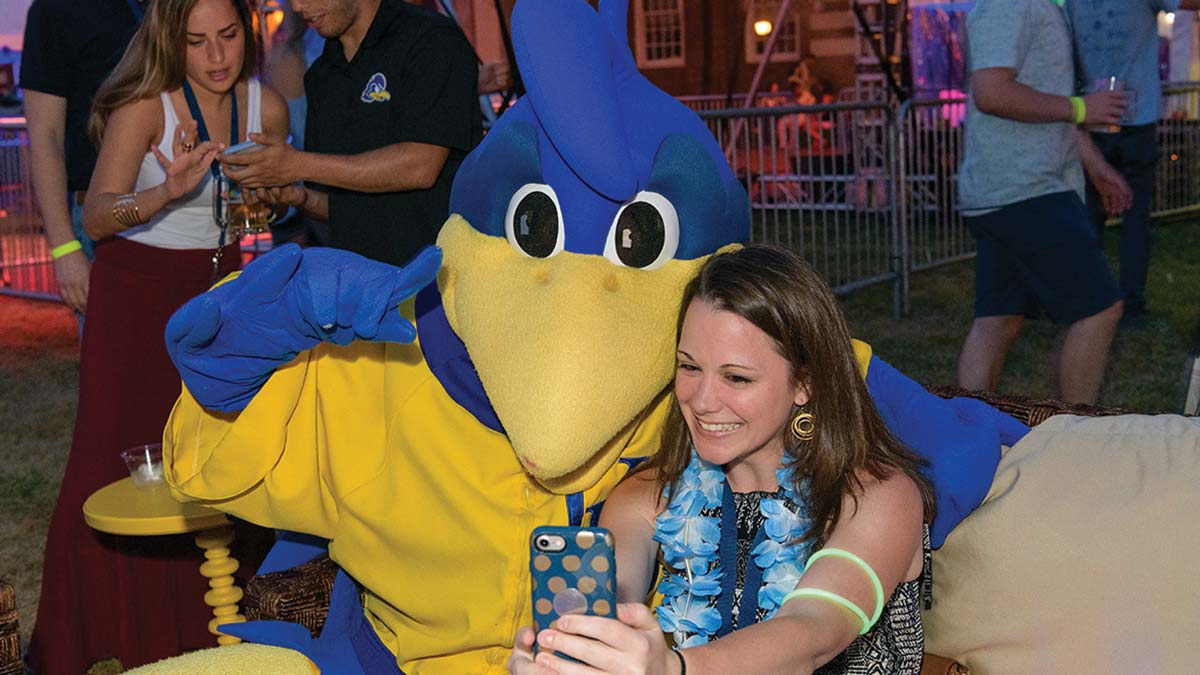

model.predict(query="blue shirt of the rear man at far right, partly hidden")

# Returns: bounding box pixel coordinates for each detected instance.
[1067,0,1180,125]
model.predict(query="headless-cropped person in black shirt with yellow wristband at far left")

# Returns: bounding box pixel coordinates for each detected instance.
[19,0,142,313]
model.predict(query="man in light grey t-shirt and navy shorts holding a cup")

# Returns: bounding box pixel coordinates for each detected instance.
[959,0,1134,402]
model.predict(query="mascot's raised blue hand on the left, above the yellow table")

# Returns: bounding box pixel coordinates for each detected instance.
[166,244,442,412]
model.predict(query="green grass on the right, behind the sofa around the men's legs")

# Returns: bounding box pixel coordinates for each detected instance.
[842,222,1200,412]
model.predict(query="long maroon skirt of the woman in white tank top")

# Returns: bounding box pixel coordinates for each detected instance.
[29,238,267,675]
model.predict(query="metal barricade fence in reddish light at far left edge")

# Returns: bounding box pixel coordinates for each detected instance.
[0,119,59,299]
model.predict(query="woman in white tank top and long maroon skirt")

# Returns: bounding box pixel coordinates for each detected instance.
[30,0,288,673]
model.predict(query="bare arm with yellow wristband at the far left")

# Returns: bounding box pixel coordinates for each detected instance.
[25,89,91,313]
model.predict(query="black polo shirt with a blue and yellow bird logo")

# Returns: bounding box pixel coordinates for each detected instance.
[305,0,482,264]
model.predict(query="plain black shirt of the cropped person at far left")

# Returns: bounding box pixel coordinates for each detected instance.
[18,0,138,190]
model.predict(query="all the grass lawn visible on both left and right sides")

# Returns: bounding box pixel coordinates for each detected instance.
[0,222,1200,653]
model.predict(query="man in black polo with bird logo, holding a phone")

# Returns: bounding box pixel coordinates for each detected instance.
[221,0,481,265]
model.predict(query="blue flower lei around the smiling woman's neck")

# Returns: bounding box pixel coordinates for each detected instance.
[654,449,811,649]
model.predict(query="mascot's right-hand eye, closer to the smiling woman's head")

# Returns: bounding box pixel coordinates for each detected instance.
[604,191,679,269]
